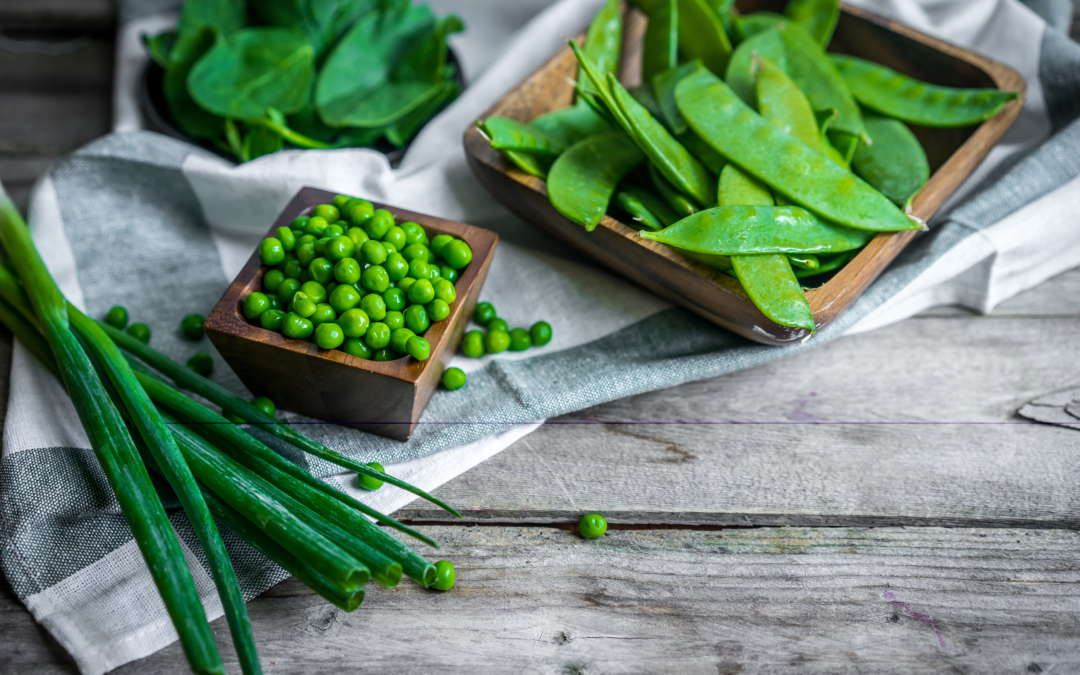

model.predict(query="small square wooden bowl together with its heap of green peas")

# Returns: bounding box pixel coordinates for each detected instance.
[204,188,498,441]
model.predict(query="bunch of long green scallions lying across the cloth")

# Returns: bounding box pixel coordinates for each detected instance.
[0,180,460,674]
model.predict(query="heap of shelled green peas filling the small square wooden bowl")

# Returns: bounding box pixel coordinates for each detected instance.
[242,194,473,361]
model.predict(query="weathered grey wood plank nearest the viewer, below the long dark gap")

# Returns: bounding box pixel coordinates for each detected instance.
[54,527,1067,674]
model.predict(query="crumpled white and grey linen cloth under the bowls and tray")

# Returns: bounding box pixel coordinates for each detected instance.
[6,0,1080,674]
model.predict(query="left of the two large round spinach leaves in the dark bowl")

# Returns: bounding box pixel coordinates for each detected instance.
[188,28,315,119]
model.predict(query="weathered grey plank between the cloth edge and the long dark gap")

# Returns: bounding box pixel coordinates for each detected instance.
[399,318,1080,527]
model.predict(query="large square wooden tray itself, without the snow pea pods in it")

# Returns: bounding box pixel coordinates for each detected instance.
[464,0,1026,345]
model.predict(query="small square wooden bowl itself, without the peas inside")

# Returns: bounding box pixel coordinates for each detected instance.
[205,188,499,441]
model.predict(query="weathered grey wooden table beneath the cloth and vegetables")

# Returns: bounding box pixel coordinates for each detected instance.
[0,0,1080,674]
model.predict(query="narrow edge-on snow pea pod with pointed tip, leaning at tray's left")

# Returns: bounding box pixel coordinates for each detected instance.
[570,40,716,206]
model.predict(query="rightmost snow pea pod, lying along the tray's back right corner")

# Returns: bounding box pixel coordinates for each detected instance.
[831,54,1020,126]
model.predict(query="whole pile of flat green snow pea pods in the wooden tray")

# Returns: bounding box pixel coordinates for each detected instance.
[477,0,1018,333]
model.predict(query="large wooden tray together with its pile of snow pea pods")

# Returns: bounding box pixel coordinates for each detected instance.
[464,0,1025,345]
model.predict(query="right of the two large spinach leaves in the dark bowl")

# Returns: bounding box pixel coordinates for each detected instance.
[315,5,462,129]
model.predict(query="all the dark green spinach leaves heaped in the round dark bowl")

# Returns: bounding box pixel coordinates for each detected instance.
[145,0,464,162]
